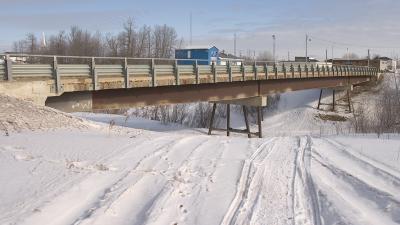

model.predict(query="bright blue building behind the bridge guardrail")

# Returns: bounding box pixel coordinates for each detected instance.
[175,46,219,65]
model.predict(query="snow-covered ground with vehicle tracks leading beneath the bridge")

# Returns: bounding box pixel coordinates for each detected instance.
[0,78,400,225]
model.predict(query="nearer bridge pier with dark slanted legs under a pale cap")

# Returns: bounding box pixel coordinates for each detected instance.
[208,96,267,138]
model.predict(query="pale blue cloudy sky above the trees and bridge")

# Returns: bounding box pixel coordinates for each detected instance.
[0,0,400,58]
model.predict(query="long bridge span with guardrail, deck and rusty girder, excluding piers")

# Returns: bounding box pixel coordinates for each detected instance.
[0,54,380,112]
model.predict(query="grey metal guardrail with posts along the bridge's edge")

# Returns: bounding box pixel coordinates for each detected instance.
[0,54,379,93]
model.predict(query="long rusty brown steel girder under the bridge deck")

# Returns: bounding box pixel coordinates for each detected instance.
[92,76,370,110]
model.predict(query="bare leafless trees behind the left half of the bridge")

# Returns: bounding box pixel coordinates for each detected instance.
[13,18,183,58]
